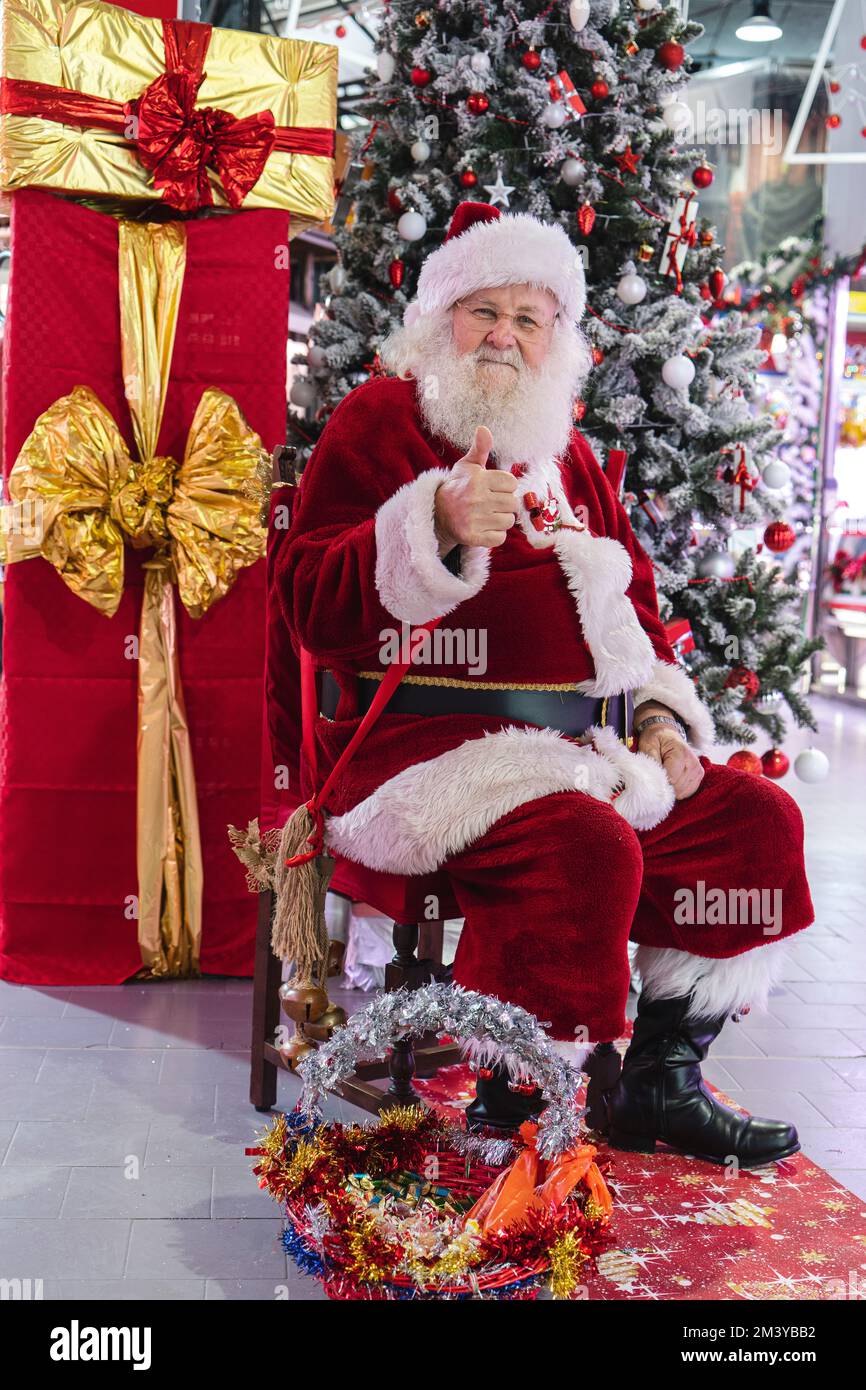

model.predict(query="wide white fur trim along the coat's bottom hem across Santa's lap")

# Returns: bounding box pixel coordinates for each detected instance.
[325,727,673,874]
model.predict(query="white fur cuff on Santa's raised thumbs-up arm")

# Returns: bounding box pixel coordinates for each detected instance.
[375,468,491,623]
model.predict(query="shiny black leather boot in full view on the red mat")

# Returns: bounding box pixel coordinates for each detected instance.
[607,994,799,1168]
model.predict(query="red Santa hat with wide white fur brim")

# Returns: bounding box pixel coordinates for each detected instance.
[413,203,587,322]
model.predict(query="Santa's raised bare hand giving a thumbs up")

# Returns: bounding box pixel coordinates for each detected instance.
[434,425,517,556]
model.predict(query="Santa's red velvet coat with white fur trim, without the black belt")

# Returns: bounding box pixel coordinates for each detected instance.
[275,378,712,873]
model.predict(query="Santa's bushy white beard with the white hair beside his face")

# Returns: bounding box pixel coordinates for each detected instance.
[381,313,592,468]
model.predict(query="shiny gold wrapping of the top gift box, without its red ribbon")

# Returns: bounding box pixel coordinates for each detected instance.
[0,0,336,234]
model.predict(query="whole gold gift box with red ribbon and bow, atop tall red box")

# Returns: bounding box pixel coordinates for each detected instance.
[0,0,336,219]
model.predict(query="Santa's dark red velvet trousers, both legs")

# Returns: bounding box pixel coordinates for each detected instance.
[445,759,813,1043]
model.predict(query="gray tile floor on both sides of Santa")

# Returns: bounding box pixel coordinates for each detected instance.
[0,702,866,1300]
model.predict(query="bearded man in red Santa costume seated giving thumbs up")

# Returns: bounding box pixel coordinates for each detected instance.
[277,204,812,1166]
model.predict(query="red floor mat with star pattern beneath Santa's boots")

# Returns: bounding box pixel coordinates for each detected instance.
[414,1066,866,1302]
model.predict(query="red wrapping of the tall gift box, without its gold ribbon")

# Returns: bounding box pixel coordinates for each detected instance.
[0,189,289,984]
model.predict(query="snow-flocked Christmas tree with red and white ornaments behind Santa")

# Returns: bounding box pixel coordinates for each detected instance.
[292,0,816,744]
